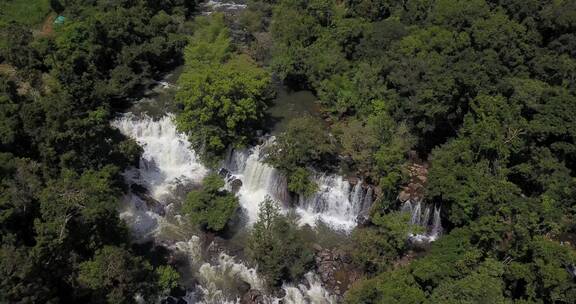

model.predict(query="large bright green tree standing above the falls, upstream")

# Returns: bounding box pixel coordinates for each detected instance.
[176,15,271,161]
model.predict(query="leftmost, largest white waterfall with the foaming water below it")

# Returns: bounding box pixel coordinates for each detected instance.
[112,114,207,241]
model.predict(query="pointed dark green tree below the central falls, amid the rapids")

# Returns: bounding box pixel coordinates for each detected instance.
[247,198,314,287]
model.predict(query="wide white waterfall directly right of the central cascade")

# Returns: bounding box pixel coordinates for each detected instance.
[296,175,372,232]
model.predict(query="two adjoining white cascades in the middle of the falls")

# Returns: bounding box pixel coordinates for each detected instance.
[224,138,373,232]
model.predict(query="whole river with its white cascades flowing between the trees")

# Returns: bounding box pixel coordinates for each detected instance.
[112,1,444,304]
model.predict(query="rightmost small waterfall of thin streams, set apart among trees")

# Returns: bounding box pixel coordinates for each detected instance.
[401,200,442,243]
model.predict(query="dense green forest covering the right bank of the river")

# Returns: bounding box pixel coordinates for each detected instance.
[238,0,576,303]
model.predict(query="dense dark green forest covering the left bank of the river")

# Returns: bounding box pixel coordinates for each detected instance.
[0,0,194,303]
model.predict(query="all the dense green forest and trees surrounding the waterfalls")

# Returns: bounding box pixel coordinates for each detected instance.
[0,0,576,304]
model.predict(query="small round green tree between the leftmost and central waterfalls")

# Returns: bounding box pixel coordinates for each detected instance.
[182,173,238,231]
